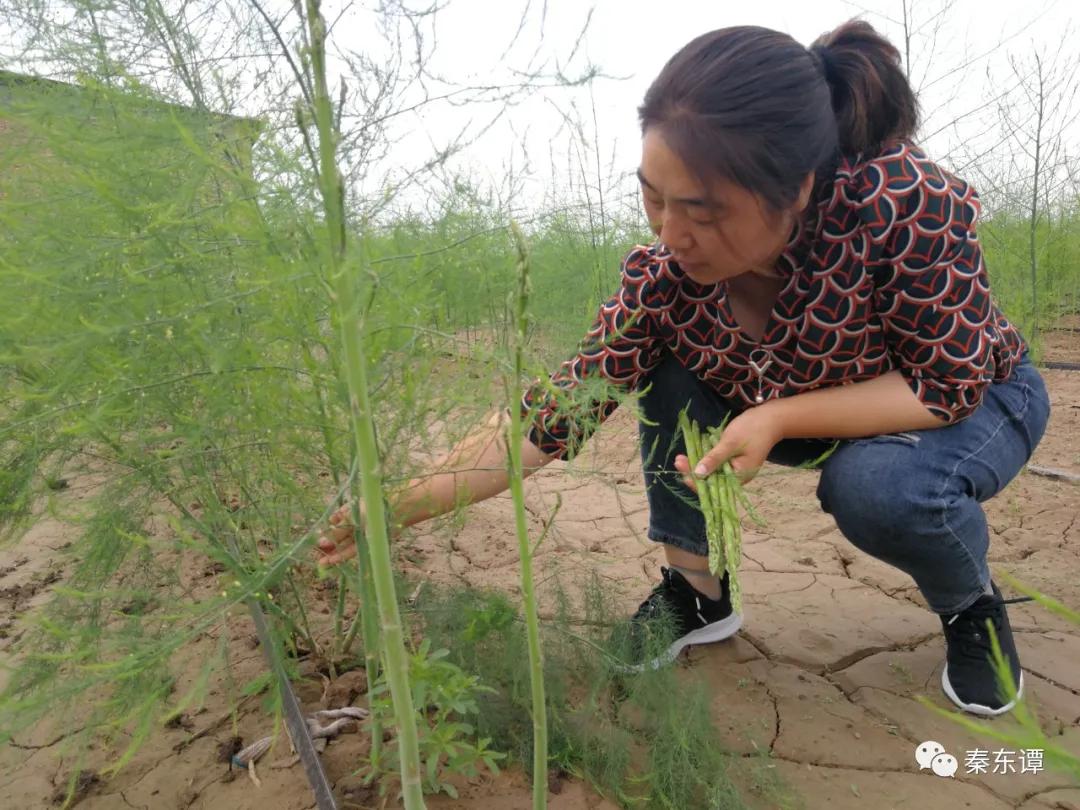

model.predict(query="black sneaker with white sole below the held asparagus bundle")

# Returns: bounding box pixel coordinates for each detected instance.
[612,567,742,673]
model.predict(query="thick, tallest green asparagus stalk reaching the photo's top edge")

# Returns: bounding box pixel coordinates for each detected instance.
[305,0,424,810]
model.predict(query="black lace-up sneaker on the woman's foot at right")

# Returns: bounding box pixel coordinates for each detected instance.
[941,582,1031,717]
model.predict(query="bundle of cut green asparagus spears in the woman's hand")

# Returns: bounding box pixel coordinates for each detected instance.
[679,410,762,613]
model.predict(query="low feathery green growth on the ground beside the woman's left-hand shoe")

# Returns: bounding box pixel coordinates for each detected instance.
[416,576,786,809]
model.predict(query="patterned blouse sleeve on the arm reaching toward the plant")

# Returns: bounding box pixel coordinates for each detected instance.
[521,247,660,459]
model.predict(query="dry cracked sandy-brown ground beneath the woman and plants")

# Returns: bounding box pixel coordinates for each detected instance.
[0,332,1080,810]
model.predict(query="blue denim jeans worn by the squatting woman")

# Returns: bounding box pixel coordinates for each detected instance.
[639,354,1050,615]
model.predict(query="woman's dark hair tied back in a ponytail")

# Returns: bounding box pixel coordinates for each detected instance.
[637,19,918,208]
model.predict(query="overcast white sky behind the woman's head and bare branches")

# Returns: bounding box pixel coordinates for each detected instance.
[0,0,1080,217]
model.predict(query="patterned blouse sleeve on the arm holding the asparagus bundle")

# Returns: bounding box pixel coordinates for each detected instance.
[860,152,999,422]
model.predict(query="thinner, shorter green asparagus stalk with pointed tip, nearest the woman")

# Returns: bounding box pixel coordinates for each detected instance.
[507,222,548,810]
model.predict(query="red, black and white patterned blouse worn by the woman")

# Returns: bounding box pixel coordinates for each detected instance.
[522,144,1025,458]
